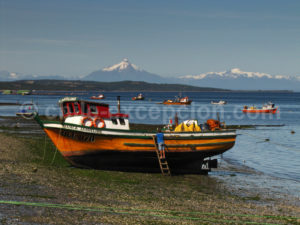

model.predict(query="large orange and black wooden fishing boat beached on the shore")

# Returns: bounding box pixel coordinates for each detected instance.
[35,98,236,172]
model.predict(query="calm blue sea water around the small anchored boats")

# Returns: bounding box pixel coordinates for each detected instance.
[0,92,300,196]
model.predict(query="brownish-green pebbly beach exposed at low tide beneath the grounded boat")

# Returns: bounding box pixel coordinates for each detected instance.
[0,120,300,224]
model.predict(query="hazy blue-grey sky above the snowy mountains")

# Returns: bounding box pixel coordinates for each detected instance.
[0,0,300,77]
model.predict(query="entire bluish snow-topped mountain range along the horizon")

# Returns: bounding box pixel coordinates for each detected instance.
[0,58,300,91]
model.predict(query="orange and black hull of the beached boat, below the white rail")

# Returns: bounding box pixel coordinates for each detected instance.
[44,127,236,171]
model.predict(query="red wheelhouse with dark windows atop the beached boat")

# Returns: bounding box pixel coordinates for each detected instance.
[59,97,128,118]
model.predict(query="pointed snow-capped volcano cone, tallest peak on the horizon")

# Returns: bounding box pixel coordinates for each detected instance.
[83,58,171,83]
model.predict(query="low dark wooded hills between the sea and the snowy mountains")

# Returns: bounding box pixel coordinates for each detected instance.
[0,80,294,94]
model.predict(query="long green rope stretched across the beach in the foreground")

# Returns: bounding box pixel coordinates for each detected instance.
[0,200,300,225]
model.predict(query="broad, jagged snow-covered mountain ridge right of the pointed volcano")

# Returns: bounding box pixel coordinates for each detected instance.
[180,68,291,80]
